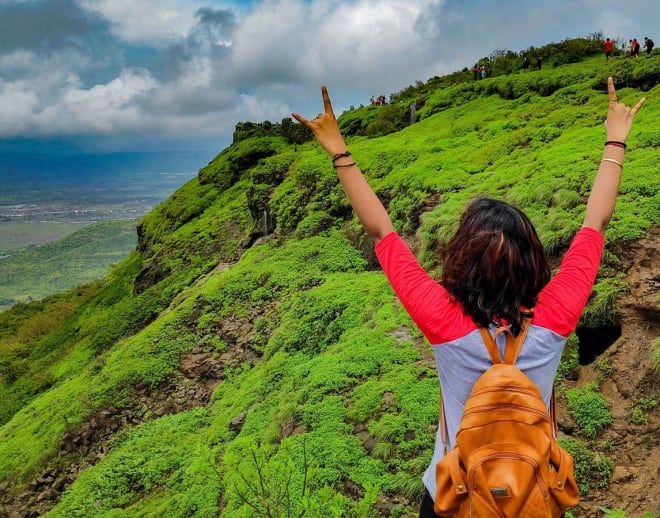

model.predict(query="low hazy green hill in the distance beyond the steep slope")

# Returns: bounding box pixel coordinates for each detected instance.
[0,221,137,311]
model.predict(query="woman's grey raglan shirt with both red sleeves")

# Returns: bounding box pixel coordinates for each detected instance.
[376,228,604,494]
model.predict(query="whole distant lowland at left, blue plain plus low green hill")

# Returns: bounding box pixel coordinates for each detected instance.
[0,150,208,311]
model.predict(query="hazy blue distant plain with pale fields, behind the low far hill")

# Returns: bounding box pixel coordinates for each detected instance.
[0,151,208,250]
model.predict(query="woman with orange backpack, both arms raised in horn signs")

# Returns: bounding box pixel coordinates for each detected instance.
[292,77,645,518]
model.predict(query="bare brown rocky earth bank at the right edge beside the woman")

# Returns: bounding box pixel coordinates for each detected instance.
[563,233,660,517]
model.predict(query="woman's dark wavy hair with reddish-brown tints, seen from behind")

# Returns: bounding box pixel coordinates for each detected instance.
[442,198,550,335]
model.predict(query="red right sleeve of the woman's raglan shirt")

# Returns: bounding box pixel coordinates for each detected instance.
[533,227,604,336]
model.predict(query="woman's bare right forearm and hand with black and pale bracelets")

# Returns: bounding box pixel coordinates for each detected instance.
[582,77,646,234]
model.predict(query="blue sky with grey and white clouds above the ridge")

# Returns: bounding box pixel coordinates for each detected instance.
[0,0,660,156]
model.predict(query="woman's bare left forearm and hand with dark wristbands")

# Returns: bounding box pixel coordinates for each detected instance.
[292,86,394,243]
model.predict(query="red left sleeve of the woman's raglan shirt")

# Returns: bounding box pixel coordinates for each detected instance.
[376,232,476,345]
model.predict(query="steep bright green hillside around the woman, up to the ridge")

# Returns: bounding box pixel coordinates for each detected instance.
[0,47,660,518]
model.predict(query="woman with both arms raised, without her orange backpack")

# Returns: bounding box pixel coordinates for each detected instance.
[293,77,645,518]
